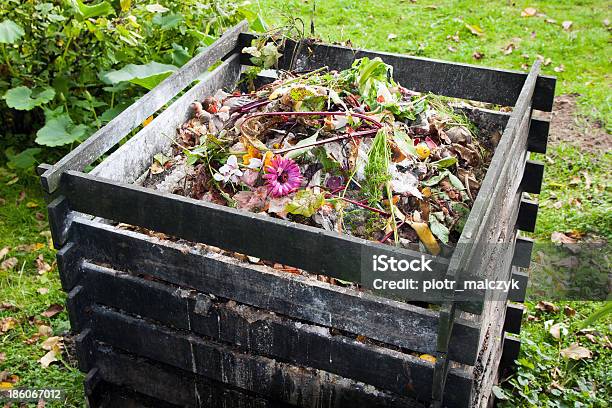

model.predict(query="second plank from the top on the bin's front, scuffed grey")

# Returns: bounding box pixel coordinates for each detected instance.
[64,220,478,364]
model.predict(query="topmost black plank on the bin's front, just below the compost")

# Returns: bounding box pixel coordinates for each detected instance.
[61,171,447,288]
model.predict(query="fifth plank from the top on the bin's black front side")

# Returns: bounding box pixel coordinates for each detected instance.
[85,342,289,408]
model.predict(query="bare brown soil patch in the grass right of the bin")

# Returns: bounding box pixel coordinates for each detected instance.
[548,94,612,153]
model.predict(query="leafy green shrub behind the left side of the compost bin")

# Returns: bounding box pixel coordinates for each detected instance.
[0,0,263,168]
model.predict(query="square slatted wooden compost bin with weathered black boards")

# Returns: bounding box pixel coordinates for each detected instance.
[40,23,555,407]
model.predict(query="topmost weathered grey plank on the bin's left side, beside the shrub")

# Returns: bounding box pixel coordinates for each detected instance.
[41,21,248,193]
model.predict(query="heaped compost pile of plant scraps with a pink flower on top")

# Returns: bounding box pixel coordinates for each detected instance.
[150,58,493,254]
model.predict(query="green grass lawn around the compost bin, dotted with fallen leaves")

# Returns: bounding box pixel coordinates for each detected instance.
[0,0,612,407]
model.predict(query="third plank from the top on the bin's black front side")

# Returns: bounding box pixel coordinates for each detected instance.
[68,265,471,406]
